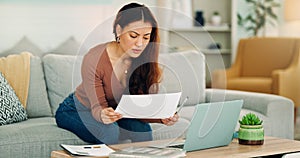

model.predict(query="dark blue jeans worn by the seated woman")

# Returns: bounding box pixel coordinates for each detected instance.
[55,93,152,144]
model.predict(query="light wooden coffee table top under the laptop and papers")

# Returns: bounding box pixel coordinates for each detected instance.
[51,137,300,158]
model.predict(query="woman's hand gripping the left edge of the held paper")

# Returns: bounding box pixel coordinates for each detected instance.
[100,107,122,124]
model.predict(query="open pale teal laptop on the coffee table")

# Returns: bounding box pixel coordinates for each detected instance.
[168,100,243,151]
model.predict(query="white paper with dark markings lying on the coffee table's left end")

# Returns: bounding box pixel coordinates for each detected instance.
[61,144,114,157]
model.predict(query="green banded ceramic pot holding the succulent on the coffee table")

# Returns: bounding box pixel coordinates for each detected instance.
[238,125,264,145]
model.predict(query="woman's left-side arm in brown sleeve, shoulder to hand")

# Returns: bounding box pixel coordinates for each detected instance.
[81,47,121,124]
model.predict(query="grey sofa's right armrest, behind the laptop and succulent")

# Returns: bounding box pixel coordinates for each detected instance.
[206,89,294,139]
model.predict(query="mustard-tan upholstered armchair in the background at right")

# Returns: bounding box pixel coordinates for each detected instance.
[212,37,300,107]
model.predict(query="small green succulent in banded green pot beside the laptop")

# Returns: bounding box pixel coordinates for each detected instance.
[238,113,264,145]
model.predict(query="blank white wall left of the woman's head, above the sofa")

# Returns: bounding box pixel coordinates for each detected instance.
[0,0,156,52]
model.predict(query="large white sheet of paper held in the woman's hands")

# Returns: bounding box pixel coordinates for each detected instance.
[115,92,181,119]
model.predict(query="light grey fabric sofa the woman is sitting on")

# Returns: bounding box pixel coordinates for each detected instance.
[0,51,294,158]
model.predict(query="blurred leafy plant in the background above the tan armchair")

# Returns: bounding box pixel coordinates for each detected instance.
[237,0,280,36]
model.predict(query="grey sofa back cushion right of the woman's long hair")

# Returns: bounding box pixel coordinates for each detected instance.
[159,50,205,105]
